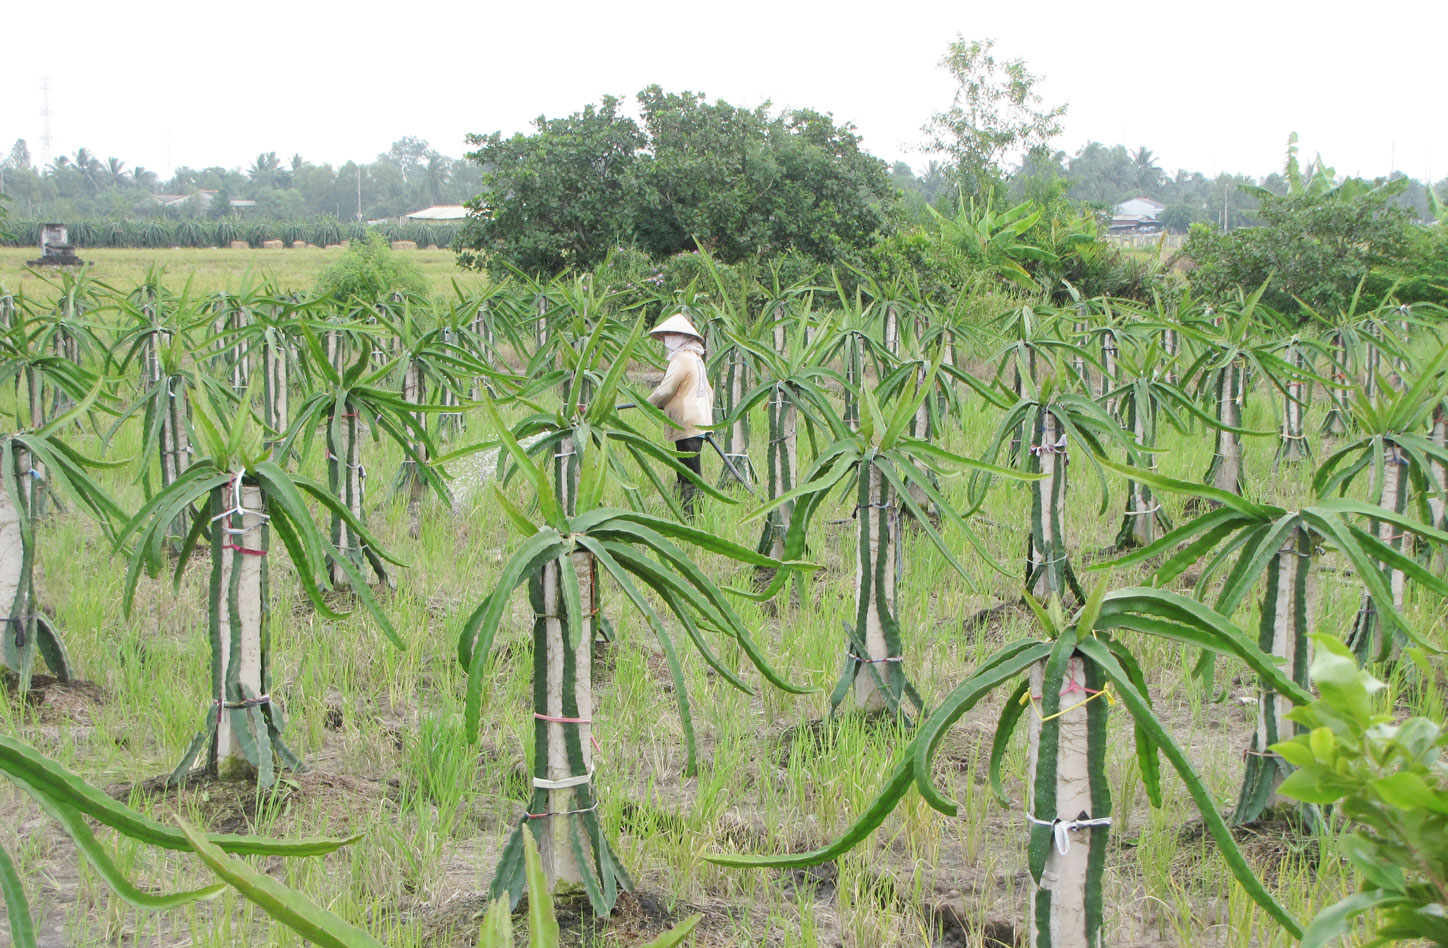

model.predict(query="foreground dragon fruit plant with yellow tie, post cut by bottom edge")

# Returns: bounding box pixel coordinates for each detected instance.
[705,583,1310,948]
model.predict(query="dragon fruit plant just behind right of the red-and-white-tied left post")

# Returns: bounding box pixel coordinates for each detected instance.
[277,326,447,592]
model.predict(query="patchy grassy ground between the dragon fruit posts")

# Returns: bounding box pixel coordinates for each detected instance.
[0,252,1424,948]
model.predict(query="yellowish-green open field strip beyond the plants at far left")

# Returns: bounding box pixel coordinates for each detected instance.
[0,247,487,300]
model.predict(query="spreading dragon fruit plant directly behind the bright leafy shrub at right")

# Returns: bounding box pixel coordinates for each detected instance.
[1092,462,1448,822]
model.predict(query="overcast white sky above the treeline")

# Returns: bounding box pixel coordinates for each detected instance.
[0,0,1448,178]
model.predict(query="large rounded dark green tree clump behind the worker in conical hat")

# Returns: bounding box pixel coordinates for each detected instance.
[460,85,895,274]
